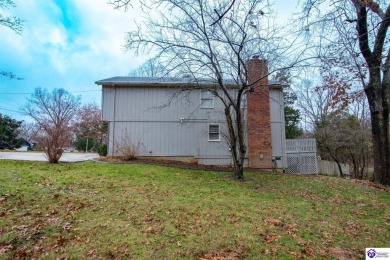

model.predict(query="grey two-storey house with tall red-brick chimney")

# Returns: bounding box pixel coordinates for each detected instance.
[96,59,286,168]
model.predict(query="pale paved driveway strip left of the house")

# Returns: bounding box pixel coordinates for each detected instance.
[0,152,99,162]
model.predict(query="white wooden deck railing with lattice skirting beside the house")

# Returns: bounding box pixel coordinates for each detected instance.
[286,139,318,174]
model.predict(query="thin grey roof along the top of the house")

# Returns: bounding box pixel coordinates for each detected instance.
[95,76,287,88]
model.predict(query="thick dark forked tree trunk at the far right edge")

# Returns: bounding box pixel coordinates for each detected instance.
[356,5,390,185]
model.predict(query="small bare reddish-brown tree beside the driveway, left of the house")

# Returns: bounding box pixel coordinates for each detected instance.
[22,88,80,163]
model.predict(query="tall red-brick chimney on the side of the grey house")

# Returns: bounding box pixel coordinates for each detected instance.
[247,57,272,168]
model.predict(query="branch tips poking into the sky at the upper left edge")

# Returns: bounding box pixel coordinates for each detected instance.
[0,0,23,80]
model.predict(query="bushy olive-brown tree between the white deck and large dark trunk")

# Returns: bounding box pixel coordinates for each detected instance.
[298,80,371,179]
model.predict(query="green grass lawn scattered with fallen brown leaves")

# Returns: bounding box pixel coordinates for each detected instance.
[0,161,390,259]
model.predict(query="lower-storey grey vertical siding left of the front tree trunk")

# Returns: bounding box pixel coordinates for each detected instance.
[110,122,230,158]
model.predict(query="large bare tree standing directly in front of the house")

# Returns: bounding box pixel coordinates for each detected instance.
[113,0,298,179]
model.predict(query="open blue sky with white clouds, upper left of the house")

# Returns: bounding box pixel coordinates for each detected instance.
[0,0,297,122]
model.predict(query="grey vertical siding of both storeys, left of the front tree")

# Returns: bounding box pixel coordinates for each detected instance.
[103,87,230,163]
